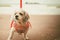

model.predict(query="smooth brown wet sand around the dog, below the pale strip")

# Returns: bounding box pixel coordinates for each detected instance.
[0,15,60,40]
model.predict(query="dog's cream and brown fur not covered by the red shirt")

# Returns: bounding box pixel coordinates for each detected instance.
[8,10,29,40]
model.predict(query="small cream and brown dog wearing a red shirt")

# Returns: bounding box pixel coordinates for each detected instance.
[8,10,31,40]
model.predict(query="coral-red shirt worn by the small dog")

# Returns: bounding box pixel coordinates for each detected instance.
[10,20,31,31]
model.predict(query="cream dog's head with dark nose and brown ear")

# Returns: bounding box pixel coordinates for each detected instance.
[14,10,29,22]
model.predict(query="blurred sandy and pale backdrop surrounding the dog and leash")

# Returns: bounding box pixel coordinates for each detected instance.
[0,0,60,40]
